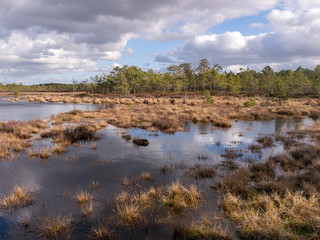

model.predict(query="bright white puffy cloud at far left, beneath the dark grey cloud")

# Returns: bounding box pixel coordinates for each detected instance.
[0,32,96,75]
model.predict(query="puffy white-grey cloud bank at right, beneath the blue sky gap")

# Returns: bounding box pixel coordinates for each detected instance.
[170,2,320,70]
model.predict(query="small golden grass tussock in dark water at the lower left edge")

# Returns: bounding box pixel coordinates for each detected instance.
[0,186,35,210]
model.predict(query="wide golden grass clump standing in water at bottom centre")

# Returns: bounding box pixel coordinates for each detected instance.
[114,182,200,227]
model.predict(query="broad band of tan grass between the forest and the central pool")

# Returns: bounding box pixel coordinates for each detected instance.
[20,95,319,133]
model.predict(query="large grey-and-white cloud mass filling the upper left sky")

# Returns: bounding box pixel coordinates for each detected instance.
[0,0,278,82]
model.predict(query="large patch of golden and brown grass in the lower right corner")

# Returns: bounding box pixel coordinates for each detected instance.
[221,124,320,239]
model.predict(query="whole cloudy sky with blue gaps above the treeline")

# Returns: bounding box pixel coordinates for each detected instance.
[0,0,320,84]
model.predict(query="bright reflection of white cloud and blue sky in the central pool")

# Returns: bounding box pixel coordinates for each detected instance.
[128,119,312,161]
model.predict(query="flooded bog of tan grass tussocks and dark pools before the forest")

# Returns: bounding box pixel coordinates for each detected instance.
[0,94,320,239]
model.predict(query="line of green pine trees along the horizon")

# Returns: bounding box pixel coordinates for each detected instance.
[0,59,320,98]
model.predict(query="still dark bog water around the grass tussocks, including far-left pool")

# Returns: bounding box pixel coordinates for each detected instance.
[0,102,312,239]
